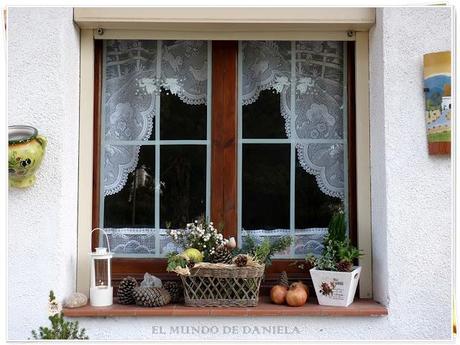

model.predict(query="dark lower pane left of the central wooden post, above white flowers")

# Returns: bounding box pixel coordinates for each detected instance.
[160,145,206,229]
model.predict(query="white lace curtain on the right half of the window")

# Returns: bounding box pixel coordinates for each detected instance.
[241,41,345,198]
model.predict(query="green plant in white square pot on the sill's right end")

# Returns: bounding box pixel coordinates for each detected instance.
[305,210,362,307]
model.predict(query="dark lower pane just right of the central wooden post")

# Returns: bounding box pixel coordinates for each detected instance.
[242,144,290,230]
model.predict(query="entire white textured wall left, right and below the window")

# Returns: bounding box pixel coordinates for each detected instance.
[8,8,452,340]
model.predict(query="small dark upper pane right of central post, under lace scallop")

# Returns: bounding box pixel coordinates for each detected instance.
[243,90,286,138]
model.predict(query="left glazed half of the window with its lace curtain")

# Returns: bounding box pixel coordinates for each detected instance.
[99,40,211,258]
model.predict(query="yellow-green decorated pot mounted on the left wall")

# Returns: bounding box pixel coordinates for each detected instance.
[8,126,46,188]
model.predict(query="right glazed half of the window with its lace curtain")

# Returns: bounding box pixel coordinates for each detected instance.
[238,41,348,258]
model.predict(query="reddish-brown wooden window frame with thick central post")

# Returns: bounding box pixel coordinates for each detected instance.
[92,40,357,293]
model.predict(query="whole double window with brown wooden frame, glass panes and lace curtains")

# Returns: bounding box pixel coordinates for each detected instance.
[93,40,356,286]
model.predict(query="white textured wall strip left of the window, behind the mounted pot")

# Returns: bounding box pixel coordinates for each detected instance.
[8,8,80,339]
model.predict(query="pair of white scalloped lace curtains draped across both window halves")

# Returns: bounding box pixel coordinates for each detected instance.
[103,40,345,198]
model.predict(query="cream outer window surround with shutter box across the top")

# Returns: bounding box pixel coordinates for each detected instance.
[74,7,378,298]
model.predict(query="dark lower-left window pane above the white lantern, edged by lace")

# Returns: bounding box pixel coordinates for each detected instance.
[104,146,155,228]
